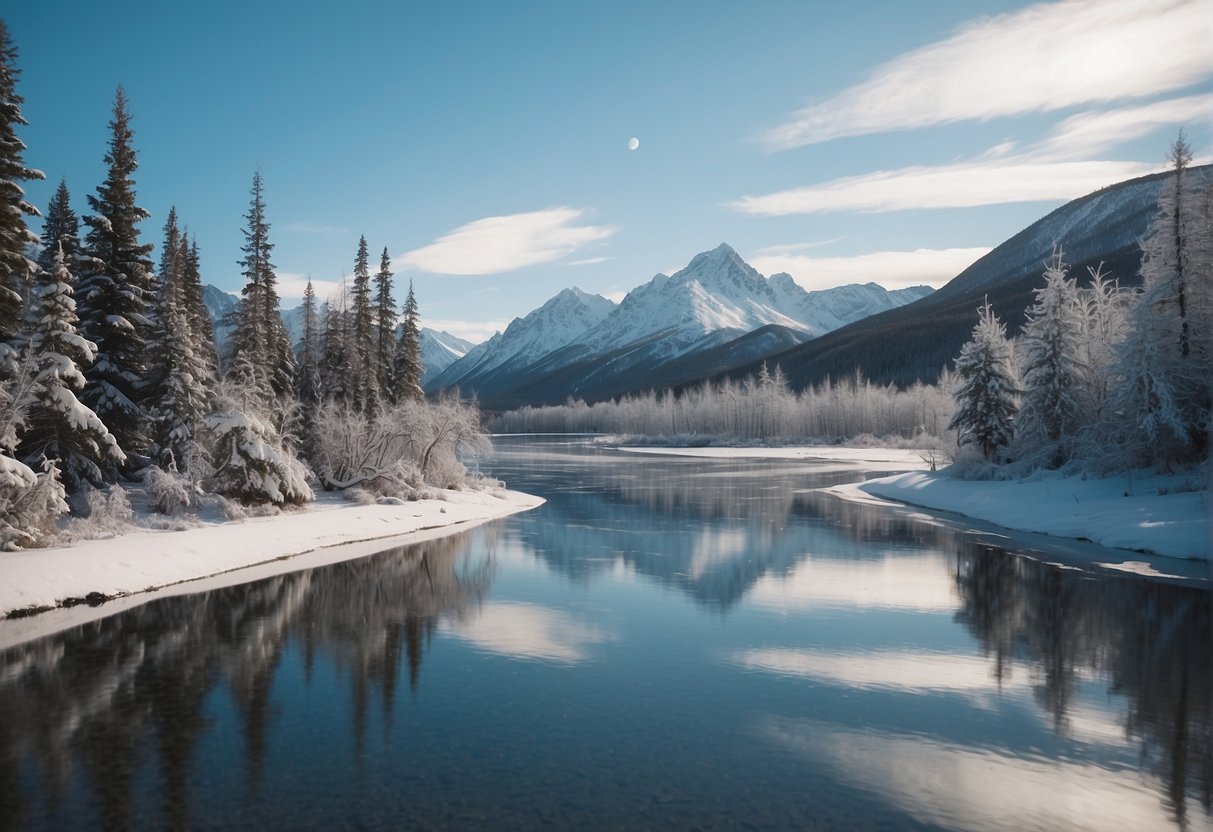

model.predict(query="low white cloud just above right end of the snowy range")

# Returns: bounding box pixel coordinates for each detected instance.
[748,246,990,290]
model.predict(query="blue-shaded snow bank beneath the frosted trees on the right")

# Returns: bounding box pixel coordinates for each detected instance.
[849,471,1213,560]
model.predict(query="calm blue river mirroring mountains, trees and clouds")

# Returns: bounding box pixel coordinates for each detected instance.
[0,438,1213,831]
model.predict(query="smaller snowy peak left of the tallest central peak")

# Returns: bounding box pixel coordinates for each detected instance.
[427,287,615,389]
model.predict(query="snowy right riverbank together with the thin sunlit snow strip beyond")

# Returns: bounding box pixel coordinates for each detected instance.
[622,446,1213,560]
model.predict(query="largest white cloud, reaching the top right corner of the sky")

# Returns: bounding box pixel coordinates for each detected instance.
[761,0,1213,150]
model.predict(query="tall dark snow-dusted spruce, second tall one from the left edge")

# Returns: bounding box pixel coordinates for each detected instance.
[76,87,153,480]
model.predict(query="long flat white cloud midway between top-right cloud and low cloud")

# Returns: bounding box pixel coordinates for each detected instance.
[731,160,1163,217]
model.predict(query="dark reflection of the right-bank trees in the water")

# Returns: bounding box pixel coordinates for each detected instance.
[956,548,1213,830]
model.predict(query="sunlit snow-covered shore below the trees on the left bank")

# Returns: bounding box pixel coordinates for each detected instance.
[0,489,543,616]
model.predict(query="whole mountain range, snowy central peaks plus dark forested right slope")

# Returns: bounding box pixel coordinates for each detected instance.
[204,166,1198,410]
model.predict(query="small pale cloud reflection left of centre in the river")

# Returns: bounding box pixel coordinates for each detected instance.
[442,602,614,665]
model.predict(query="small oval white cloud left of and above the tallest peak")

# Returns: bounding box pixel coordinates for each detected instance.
[393,206,616,274]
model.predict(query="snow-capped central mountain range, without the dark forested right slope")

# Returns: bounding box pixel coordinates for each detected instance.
[427,244,932,406]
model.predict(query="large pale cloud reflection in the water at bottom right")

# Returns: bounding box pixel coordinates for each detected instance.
[761,718,1161,832]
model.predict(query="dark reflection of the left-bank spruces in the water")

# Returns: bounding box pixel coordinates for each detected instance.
[0,535,492,830]
